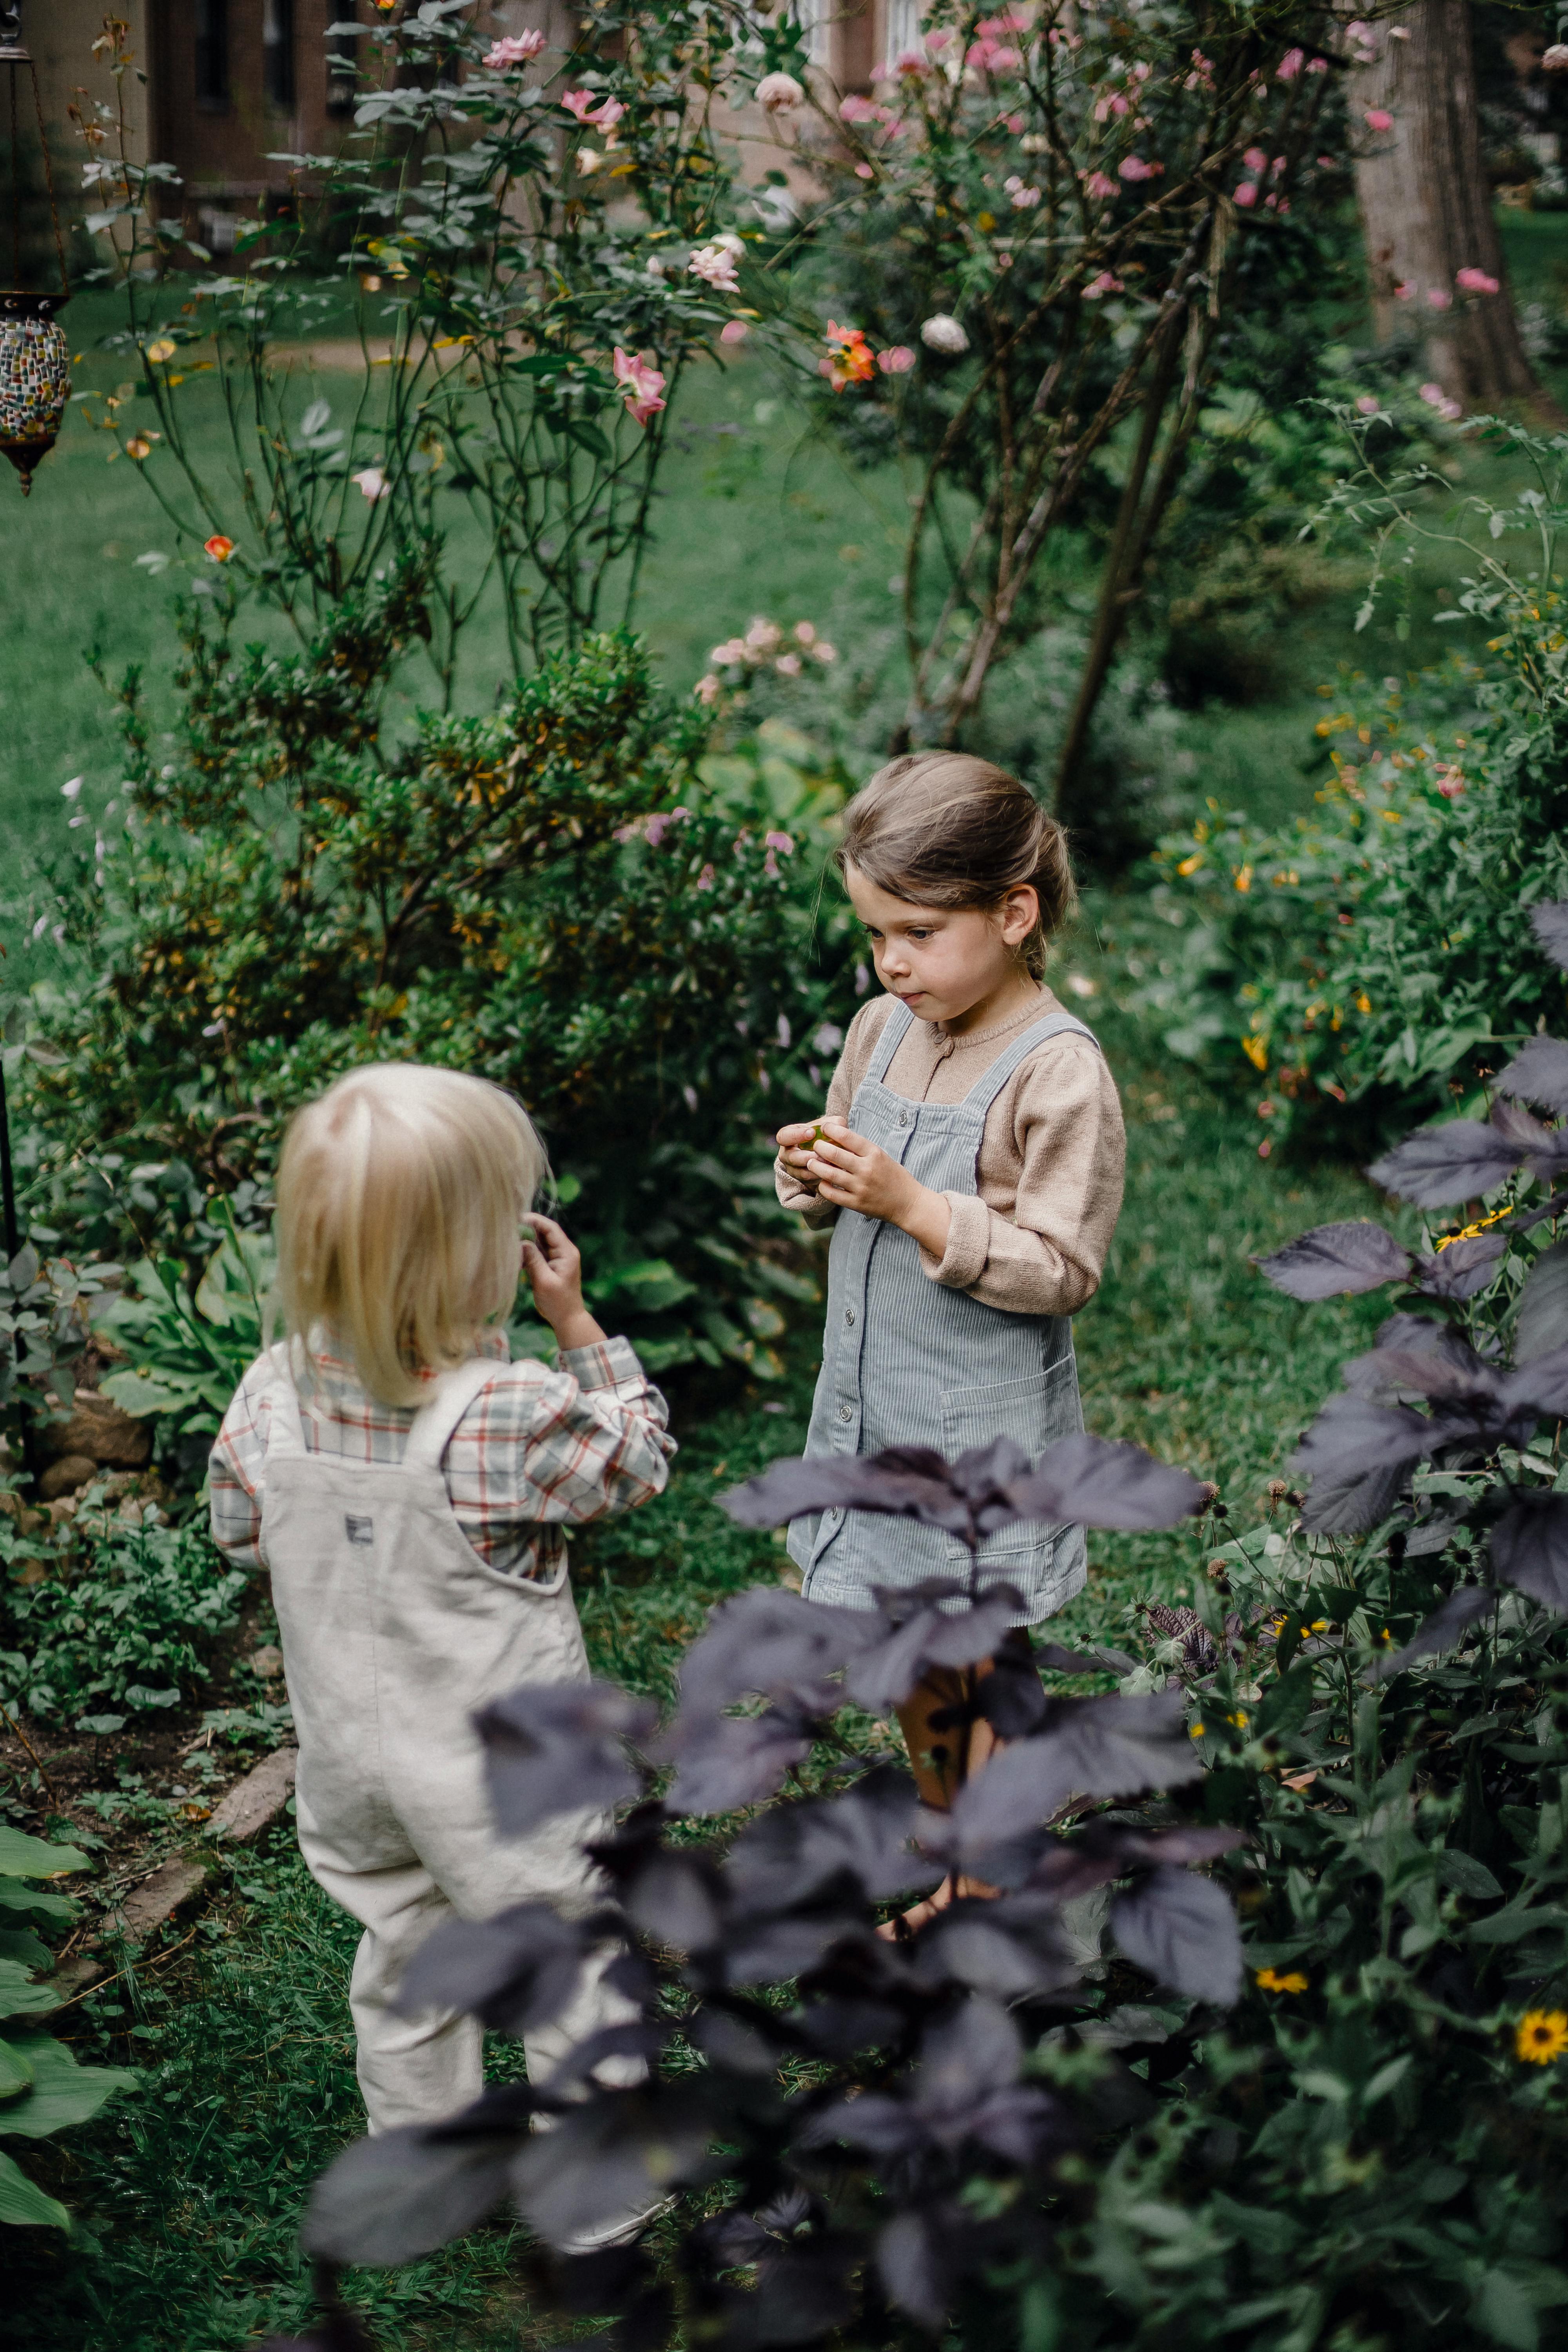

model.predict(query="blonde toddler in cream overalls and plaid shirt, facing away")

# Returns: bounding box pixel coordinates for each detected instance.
[212,1063,675,2131]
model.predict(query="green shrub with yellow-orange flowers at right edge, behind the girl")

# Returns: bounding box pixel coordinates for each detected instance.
[1122,430,1568,1141]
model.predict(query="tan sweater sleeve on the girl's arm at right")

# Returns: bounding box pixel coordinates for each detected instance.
[919,1037,1126,1315]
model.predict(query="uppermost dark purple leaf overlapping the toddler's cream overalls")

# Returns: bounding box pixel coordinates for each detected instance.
[475,1682,658,1837]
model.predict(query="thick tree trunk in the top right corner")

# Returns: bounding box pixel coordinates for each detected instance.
[1347,0,1563,423]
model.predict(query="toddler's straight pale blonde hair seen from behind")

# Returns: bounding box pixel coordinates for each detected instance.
[278,1061,550,1404]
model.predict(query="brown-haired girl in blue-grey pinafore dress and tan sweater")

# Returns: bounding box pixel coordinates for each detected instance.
[776,753,1124,1917]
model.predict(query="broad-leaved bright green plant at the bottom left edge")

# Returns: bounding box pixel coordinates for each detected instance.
[0,1825,141,2230]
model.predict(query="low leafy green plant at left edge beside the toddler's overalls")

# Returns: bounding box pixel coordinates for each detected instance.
[0,1489,249,1719]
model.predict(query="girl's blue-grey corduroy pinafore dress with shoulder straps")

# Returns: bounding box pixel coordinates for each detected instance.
[790,1004,1098,1625]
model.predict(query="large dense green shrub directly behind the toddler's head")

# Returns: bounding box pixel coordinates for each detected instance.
[12,607,849,1374]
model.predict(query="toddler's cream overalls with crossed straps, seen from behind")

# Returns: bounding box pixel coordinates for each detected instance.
[261,1348,630,2131]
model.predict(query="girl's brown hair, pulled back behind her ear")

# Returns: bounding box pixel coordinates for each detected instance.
[837,750,1077,978]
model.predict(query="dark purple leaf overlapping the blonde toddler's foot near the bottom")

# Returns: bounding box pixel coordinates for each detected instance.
[512,2084,710,2249]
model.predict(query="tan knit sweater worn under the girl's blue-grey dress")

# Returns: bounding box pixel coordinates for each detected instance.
[773,988,1126,1315]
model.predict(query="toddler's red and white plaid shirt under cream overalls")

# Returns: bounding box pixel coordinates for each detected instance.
[209,1331,675,1578]
